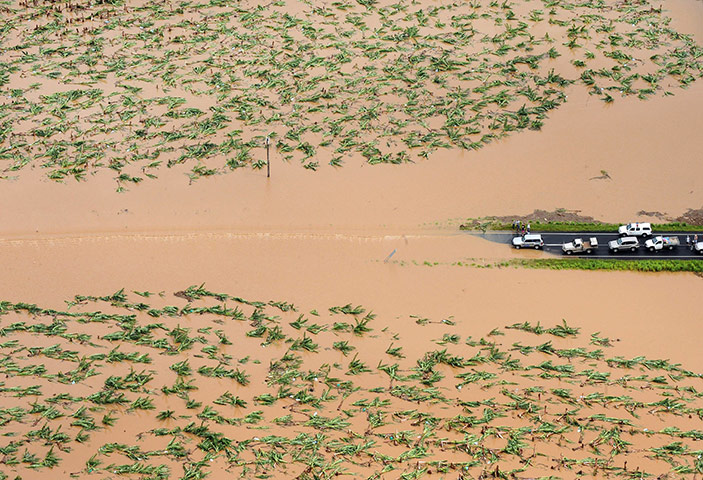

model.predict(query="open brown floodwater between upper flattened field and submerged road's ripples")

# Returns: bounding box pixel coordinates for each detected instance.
[0,76,703,236]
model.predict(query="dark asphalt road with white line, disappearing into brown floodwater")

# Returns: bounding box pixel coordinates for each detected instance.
[467,231,703,260]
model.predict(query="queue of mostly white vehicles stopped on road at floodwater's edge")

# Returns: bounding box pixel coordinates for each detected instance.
[513,222,703,255]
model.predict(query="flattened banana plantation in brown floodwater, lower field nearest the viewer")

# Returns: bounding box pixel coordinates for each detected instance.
[0,285,703,480]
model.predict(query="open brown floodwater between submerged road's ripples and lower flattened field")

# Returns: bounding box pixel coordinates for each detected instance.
[0,234,703,365]
